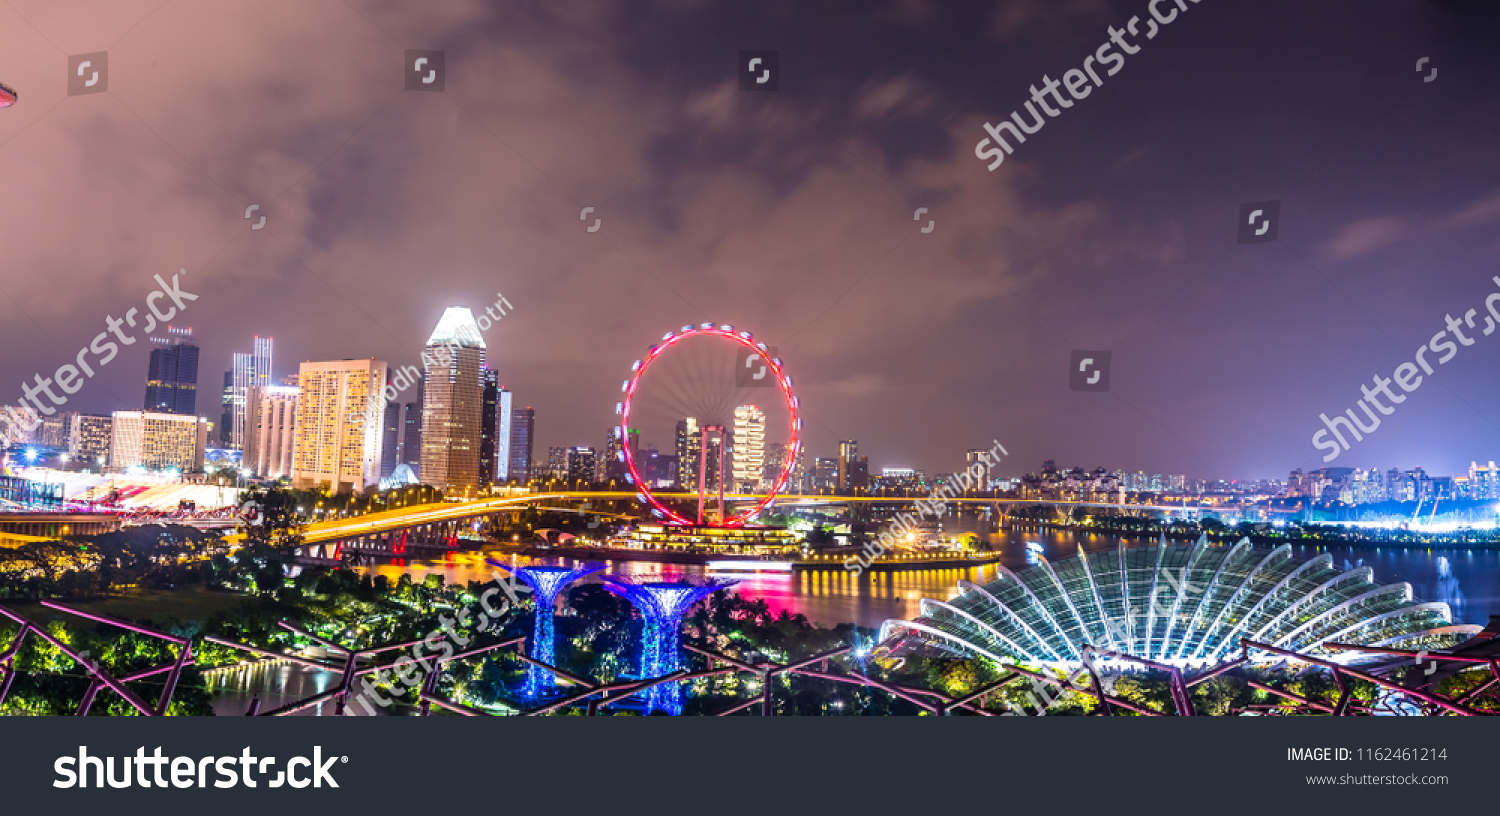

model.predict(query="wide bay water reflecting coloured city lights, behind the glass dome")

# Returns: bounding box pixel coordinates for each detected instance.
[360,530,1500,627]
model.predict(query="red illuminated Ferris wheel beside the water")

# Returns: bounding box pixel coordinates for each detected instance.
[615,323,803,527]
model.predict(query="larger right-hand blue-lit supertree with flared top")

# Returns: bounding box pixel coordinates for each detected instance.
[605,575,737,714]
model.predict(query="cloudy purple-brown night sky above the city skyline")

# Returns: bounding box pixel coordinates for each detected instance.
[0,0,1500,479]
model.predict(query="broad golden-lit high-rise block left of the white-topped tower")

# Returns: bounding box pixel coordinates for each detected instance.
[291,360,386,494]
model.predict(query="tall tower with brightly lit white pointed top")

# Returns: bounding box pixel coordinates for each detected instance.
[420,306,485,495]
